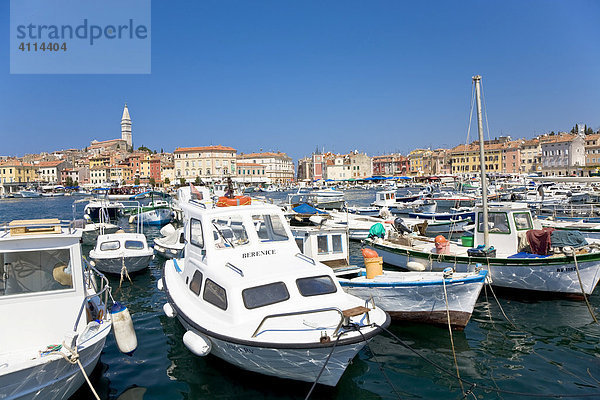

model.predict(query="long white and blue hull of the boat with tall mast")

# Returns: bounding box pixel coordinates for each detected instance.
[368,241,600,298]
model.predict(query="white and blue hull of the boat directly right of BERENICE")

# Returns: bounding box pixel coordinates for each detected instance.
[338,268,487,330]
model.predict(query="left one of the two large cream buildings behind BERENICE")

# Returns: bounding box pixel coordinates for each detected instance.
[174,145,237,182]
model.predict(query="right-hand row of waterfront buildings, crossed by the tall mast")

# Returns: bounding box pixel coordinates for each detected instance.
[298,129,600,181]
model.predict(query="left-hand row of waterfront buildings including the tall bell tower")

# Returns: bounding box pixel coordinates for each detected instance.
[0,105,295,194]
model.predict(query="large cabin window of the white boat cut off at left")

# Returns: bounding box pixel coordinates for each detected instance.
[0,249,73,296]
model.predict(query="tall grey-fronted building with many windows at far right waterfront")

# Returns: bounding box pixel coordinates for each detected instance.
[540,133,586,176]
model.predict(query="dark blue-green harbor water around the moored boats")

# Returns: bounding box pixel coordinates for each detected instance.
[0,190,600,400]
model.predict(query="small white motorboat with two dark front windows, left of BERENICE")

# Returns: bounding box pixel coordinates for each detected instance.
[90,231,154,274]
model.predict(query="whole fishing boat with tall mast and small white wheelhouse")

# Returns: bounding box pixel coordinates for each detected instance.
[365,76,600,299]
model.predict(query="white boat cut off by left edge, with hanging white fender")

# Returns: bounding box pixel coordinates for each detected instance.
[0,219,113,399]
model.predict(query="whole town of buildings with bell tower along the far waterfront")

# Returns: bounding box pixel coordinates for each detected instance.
[0,105,600,195]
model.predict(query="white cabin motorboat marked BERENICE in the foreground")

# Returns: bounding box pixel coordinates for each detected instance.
[158,200,390,386]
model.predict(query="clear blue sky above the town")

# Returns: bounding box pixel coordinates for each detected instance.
[0,0,600,159]
